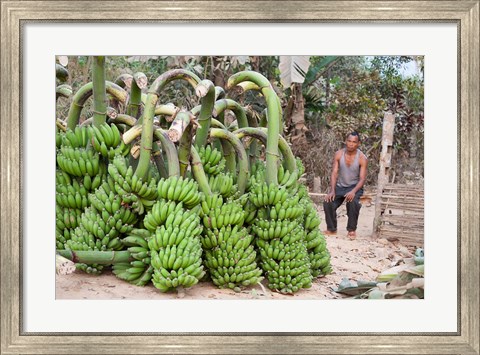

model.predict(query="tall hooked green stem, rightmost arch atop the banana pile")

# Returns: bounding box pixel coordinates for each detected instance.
[227,71,280,185]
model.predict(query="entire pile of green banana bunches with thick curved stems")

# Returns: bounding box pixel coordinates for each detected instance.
[56,62,331,294]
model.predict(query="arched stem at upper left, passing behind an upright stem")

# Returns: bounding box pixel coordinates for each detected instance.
[67,81,128,130]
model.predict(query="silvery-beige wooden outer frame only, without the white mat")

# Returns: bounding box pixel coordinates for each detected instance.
[0,0,480,354]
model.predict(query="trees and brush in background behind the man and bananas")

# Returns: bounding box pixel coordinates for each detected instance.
[57,56,424,192]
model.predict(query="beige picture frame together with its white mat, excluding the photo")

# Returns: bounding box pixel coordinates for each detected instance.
[0,0,480,354]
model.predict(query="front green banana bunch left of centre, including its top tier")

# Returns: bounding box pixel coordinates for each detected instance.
[143,177,205,292]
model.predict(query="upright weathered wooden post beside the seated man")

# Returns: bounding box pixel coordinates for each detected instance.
[372,112,395,237]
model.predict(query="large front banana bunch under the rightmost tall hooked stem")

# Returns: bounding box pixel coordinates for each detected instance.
[249,181,312,294]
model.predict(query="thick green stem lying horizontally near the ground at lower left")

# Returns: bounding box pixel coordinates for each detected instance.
[57,250,134,265]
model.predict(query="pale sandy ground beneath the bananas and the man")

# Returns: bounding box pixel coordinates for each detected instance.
[55,200,414,300]
